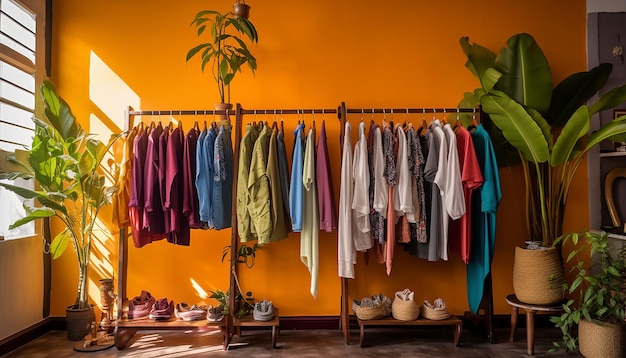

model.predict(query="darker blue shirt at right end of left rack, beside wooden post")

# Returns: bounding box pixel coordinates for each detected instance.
[211,124,234,230]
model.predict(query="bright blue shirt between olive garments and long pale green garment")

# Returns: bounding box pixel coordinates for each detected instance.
[289,123,304,232]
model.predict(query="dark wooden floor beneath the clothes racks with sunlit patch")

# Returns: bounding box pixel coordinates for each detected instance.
[4,327,580,358]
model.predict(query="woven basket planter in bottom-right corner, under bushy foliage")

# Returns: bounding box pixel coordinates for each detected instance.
[578,319,626,358]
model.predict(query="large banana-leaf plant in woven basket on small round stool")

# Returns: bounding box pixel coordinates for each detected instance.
[460,33,626,304]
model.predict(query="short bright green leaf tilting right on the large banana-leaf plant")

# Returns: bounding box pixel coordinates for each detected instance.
[551,105,590,166]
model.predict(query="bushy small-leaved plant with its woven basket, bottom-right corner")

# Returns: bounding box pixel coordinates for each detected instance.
[550,231,626,358]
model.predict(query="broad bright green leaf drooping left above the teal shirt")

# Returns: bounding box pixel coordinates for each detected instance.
[481,91,549,163]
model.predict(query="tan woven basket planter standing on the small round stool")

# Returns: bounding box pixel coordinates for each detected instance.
[513,247,564,305]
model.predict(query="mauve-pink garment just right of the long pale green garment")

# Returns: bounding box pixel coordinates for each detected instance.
[315,121,337,232]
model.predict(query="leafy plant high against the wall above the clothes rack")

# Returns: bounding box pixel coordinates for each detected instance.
[186,4,259,103]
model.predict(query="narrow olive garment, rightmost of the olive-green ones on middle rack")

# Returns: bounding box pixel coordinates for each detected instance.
[259,128,288,245]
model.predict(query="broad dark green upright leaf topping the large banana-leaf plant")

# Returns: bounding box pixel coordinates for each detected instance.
[495,33,552,114]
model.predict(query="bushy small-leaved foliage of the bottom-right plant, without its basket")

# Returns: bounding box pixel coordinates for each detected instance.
[550,231,626,350]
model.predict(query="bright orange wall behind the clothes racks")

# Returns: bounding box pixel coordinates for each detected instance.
[52,0,588,316]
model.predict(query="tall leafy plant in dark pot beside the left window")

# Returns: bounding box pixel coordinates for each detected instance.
[0,81,116,340]
